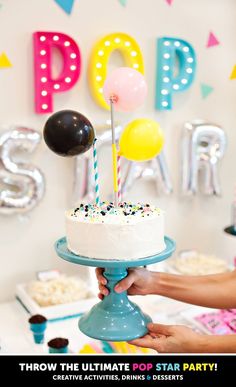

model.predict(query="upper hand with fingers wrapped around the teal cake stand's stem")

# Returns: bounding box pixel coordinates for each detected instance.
[96,268,157,300]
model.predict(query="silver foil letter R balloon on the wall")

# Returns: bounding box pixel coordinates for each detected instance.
[182,120,226,195]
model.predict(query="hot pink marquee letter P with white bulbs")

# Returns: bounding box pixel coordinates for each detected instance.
[33,32,81,114]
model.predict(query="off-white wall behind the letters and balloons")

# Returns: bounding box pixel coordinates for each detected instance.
[0,0,236,300]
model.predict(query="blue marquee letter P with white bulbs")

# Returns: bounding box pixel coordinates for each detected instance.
[156,37,196,110]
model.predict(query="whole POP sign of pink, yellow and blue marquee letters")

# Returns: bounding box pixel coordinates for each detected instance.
[33,31,196,114]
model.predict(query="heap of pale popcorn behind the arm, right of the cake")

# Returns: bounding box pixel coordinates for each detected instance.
[166,250,230,275]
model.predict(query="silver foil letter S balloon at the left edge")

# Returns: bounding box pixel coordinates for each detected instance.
[0,127,45,214]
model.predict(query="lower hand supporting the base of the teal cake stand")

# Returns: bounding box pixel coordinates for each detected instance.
[129,323,207,353]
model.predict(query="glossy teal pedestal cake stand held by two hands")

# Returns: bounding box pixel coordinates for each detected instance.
[55,237,175,341]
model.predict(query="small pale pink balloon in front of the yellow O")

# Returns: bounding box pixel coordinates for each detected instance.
[103,67,147,112]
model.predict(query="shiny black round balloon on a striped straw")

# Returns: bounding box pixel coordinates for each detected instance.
[43,110,95,157]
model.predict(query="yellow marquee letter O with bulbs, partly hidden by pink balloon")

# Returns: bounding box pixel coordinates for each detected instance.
[88,32,144,109]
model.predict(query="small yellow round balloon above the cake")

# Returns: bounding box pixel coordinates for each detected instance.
[119,118,164,161]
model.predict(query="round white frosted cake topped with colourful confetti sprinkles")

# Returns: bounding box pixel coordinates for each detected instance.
[66,202,165,260]
